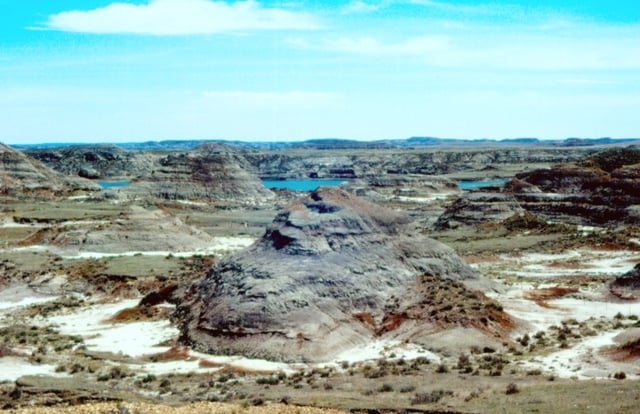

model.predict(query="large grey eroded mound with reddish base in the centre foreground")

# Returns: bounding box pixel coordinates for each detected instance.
[177,188,508,361]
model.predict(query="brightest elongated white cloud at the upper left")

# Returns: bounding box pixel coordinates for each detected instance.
[46,0,319,35]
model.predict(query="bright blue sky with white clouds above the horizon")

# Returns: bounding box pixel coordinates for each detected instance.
[0,0,640,144]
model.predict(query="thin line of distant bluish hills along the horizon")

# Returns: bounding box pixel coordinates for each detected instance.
[12,137,640,151]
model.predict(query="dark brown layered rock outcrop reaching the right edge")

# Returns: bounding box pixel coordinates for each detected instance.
[436,148,640,229]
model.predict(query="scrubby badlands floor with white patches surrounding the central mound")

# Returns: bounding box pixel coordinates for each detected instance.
[0,188,640,413]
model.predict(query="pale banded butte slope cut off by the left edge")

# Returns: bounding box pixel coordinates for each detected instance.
[0,144,100,199]
